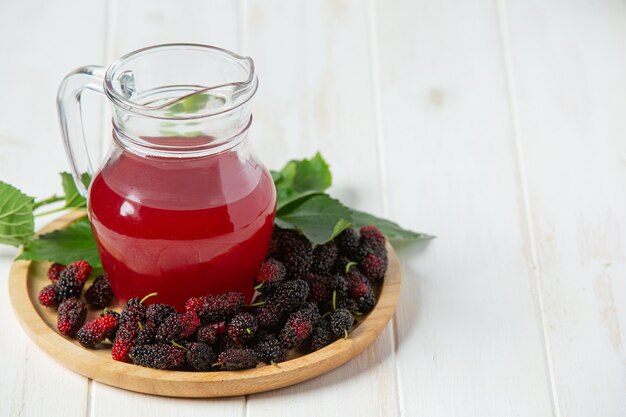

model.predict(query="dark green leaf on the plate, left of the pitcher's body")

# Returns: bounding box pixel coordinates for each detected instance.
[17,217,102,268]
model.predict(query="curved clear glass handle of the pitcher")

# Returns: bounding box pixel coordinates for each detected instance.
[57,65,106,198]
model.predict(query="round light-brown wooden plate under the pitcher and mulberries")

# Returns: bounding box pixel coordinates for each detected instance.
[9,212,402,398]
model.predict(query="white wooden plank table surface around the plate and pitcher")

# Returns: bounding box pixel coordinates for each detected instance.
[0,0,626,417]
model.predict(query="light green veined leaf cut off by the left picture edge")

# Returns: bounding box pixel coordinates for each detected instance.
[0,181,35,246]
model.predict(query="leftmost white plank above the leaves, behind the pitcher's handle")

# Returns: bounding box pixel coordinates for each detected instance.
[0,0,105,234]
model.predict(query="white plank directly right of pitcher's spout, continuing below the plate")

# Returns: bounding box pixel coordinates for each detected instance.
[243,0,398,416]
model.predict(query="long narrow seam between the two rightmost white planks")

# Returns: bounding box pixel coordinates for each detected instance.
[496,0,561,417]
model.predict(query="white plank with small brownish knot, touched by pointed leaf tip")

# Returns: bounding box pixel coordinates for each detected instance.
[375,0,553,416]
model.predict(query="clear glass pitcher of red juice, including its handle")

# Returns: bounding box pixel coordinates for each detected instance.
[57,44,276,309]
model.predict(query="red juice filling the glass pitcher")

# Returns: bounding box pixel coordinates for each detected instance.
[89,144,276,309]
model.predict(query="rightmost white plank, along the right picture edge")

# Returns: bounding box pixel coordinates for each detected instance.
[502,1,626,417]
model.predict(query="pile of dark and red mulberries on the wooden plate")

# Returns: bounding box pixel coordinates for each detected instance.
[39,226,388,371]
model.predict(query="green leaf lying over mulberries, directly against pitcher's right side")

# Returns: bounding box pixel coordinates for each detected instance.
[277,194,351,244]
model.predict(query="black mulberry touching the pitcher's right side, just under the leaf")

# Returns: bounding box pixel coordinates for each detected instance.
[276,230,313,279]
